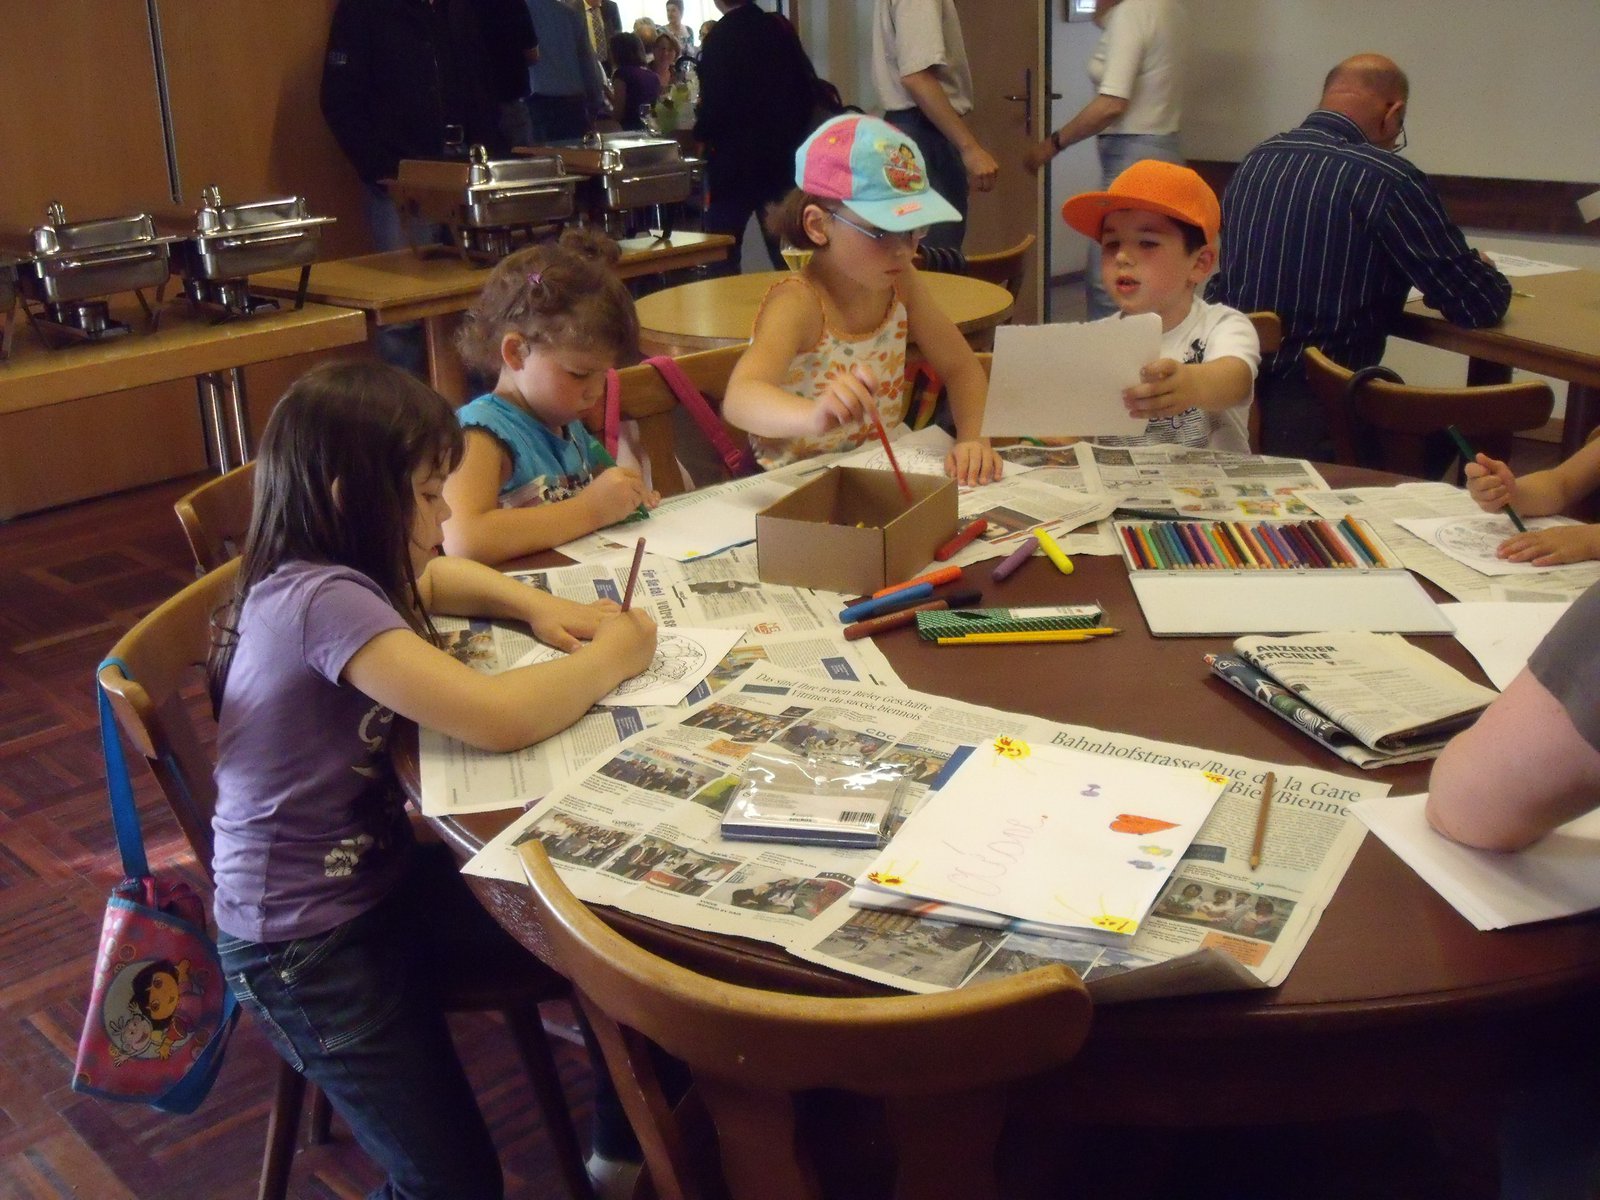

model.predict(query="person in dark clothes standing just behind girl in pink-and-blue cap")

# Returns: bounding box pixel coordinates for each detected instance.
[694,0,816,270]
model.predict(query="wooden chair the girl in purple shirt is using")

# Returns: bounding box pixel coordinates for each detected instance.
[99,558,592,1200]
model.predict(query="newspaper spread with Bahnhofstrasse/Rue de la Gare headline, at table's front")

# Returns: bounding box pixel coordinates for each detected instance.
[466,666,1389,1003]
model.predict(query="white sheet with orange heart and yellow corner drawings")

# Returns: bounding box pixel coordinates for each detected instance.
[867,738,1229,933]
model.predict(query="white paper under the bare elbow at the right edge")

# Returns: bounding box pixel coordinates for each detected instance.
[1350,795,1600,930]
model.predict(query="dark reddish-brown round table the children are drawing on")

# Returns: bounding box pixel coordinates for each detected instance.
[402,467,1600,1126]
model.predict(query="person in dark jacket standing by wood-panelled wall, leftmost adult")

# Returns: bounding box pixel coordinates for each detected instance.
[322,0,506,250]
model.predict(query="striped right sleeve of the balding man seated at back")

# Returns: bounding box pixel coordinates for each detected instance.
[1376,163,1510,330]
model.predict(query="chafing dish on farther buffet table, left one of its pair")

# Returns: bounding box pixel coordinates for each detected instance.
[389,146,578,262]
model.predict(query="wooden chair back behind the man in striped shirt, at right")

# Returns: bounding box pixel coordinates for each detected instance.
[1301,346,1555,477]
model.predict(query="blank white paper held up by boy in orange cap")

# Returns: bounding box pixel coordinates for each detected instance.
[984,312,1162,437]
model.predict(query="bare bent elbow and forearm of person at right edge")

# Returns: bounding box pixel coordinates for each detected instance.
[1427,670,1600,850]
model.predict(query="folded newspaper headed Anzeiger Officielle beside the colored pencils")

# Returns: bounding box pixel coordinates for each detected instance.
[1234,630,1499,750]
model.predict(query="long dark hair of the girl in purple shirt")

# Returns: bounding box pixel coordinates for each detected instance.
[208,362,464,709]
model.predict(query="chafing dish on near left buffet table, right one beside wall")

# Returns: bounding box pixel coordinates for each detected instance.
[173,186,334,315]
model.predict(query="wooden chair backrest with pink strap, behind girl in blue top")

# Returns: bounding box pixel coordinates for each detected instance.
[616,346,746,496]
